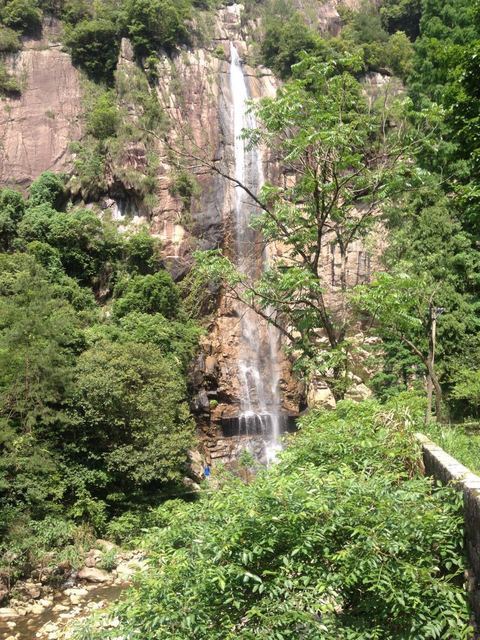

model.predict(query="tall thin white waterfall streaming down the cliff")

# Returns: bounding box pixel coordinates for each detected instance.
[230,43,281,461]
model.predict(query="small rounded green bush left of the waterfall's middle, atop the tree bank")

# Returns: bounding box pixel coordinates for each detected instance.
[113,271,180,318]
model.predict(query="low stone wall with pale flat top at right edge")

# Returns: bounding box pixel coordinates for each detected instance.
[417,434,480,639]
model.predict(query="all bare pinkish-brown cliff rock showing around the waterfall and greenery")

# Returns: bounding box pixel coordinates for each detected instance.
[0,0,396,459]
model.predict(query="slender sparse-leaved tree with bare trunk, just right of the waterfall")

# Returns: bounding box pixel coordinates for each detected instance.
[195,58,407,397]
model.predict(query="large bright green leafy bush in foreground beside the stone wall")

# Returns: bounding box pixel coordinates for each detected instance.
[79,402,469,640]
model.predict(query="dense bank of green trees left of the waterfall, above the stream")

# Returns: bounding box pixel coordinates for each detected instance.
[0,173,198,580]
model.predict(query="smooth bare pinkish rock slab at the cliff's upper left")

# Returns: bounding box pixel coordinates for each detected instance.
[0,22,82,187]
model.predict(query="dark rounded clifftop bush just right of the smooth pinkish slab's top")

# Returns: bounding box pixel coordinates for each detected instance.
[65,19,120,82]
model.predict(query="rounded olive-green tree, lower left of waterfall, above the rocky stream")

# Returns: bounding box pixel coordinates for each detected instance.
[72,341,193,495]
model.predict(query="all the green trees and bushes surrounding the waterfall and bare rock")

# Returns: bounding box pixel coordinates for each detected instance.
[0,0,480,640]
